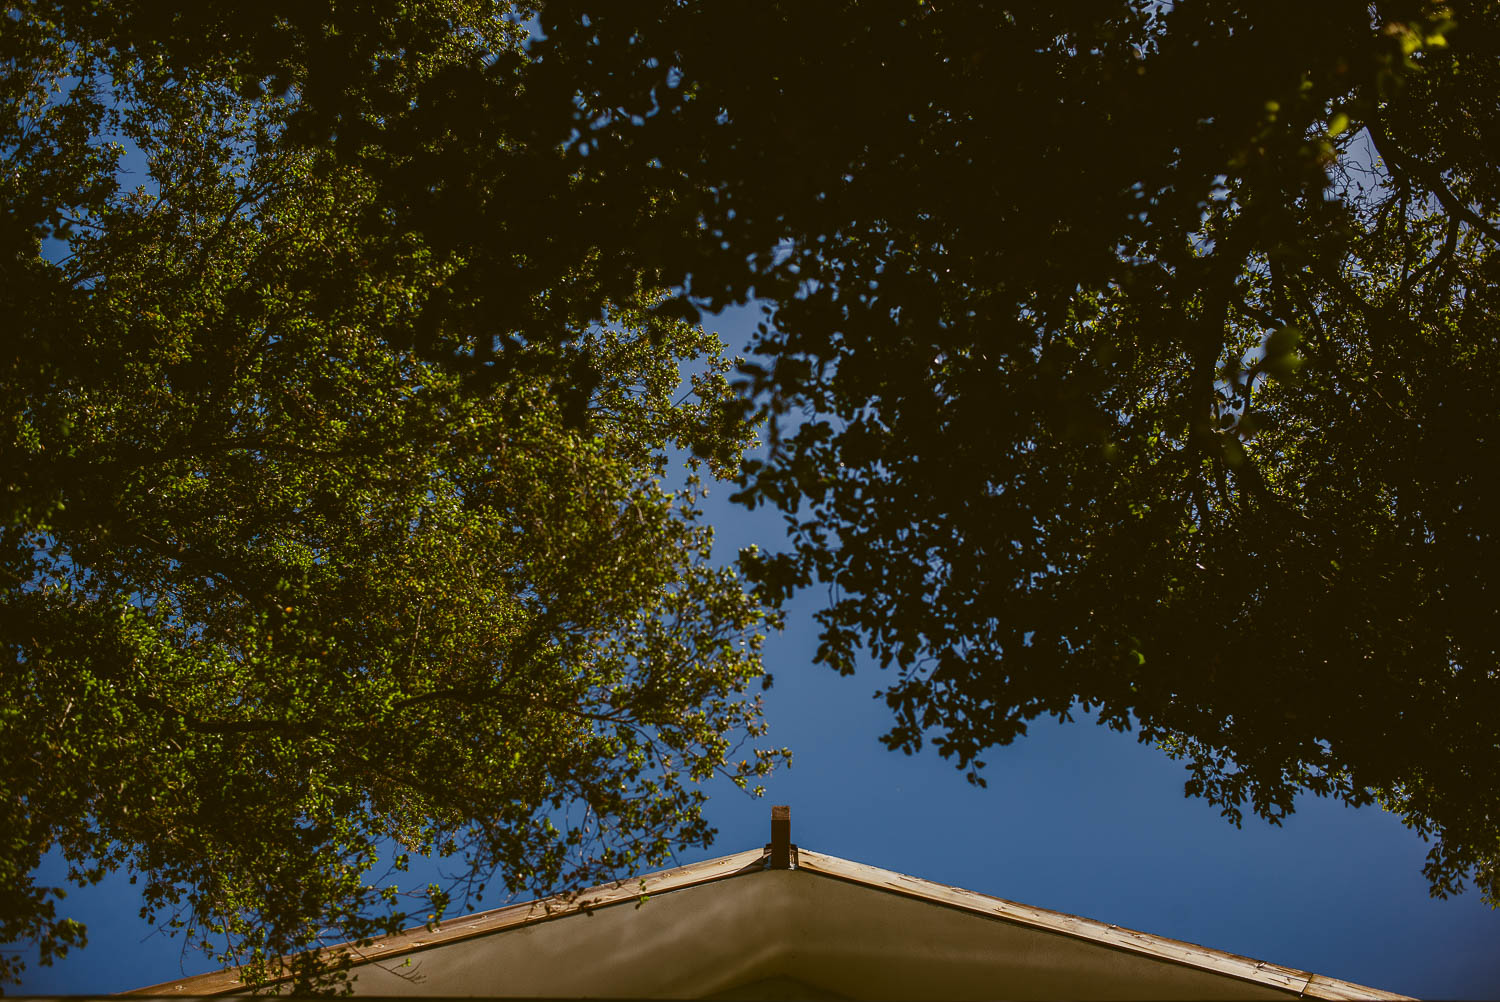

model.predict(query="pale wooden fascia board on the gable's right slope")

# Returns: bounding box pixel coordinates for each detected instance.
[797,849,1412,1002]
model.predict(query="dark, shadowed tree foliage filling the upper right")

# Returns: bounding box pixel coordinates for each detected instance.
[519,0,1500,902]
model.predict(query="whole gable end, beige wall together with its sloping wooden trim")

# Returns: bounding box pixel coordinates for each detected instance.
[131,846,1407,999]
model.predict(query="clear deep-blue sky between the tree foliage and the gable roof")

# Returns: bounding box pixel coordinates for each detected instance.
[21,314,1500,998]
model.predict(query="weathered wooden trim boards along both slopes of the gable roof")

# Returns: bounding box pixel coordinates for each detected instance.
[128,849,1409,1001]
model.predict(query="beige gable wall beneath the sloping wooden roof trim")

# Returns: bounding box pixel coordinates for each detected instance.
[343,870,1287,999]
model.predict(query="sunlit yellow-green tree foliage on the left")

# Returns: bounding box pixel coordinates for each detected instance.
[0,5,779,987]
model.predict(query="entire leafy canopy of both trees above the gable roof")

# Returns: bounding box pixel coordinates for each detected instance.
[0,0,1500,990]
